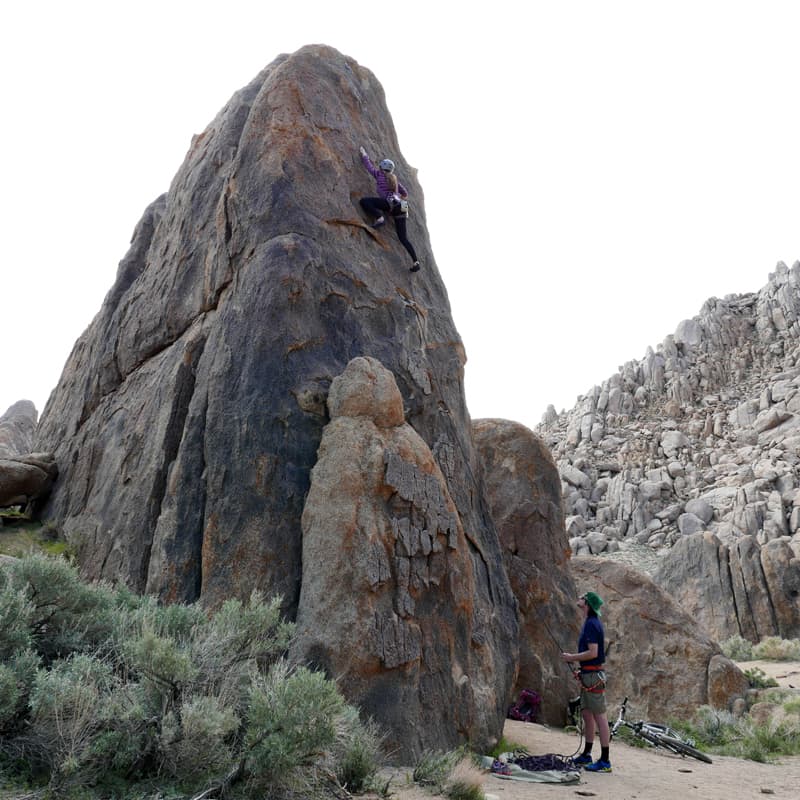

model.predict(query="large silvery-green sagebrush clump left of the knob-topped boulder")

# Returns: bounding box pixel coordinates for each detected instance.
[0,556,388,798]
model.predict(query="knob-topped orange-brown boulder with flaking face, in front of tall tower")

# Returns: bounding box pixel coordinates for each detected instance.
[294,358,516,764]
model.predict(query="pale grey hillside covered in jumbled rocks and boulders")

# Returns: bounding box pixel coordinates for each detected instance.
[538,262,800,638]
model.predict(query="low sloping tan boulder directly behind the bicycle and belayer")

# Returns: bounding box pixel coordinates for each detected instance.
[572,556,749,720]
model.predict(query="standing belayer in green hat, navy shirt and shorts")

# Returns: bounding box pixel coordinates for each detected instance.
[561,592,611,772]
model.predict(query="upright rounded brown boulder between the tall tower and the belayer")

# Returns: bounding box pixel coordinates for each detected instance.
[472,419,580,725]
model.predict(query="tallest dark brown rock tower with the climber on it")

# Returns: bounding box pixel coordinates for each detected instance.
[31,46,517,744]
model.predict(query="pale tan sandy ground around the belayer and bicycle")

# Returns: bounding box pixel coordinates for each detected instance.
[382,661,800,800]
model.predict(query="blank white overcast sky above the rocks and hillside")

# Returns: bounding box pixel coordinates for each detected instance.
[0,0,800,438]
